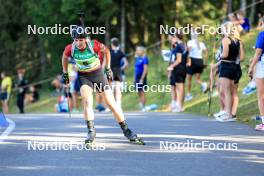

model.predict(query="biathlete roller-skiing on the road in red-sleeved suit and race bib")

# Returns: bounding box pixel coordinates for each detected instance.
[62,26,144,145]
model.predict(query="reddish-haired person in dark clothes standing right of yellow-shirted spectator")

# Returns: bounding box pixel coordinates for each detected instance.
[16,69,28,113]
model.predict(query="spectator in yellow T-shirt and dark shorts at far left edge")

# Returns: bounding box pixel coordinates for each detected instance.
[0,72,12,114]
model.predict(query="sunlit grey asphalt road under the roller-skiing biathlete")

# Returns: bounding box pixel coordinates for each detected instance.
[0,113,264,176]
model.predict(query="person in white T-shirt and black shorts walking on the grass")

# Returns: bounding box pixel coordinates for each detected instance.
[185,33,208,101]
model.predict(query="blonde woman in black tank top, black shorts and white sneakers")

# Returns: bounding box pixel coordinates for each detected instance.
[212,22,244,122]
